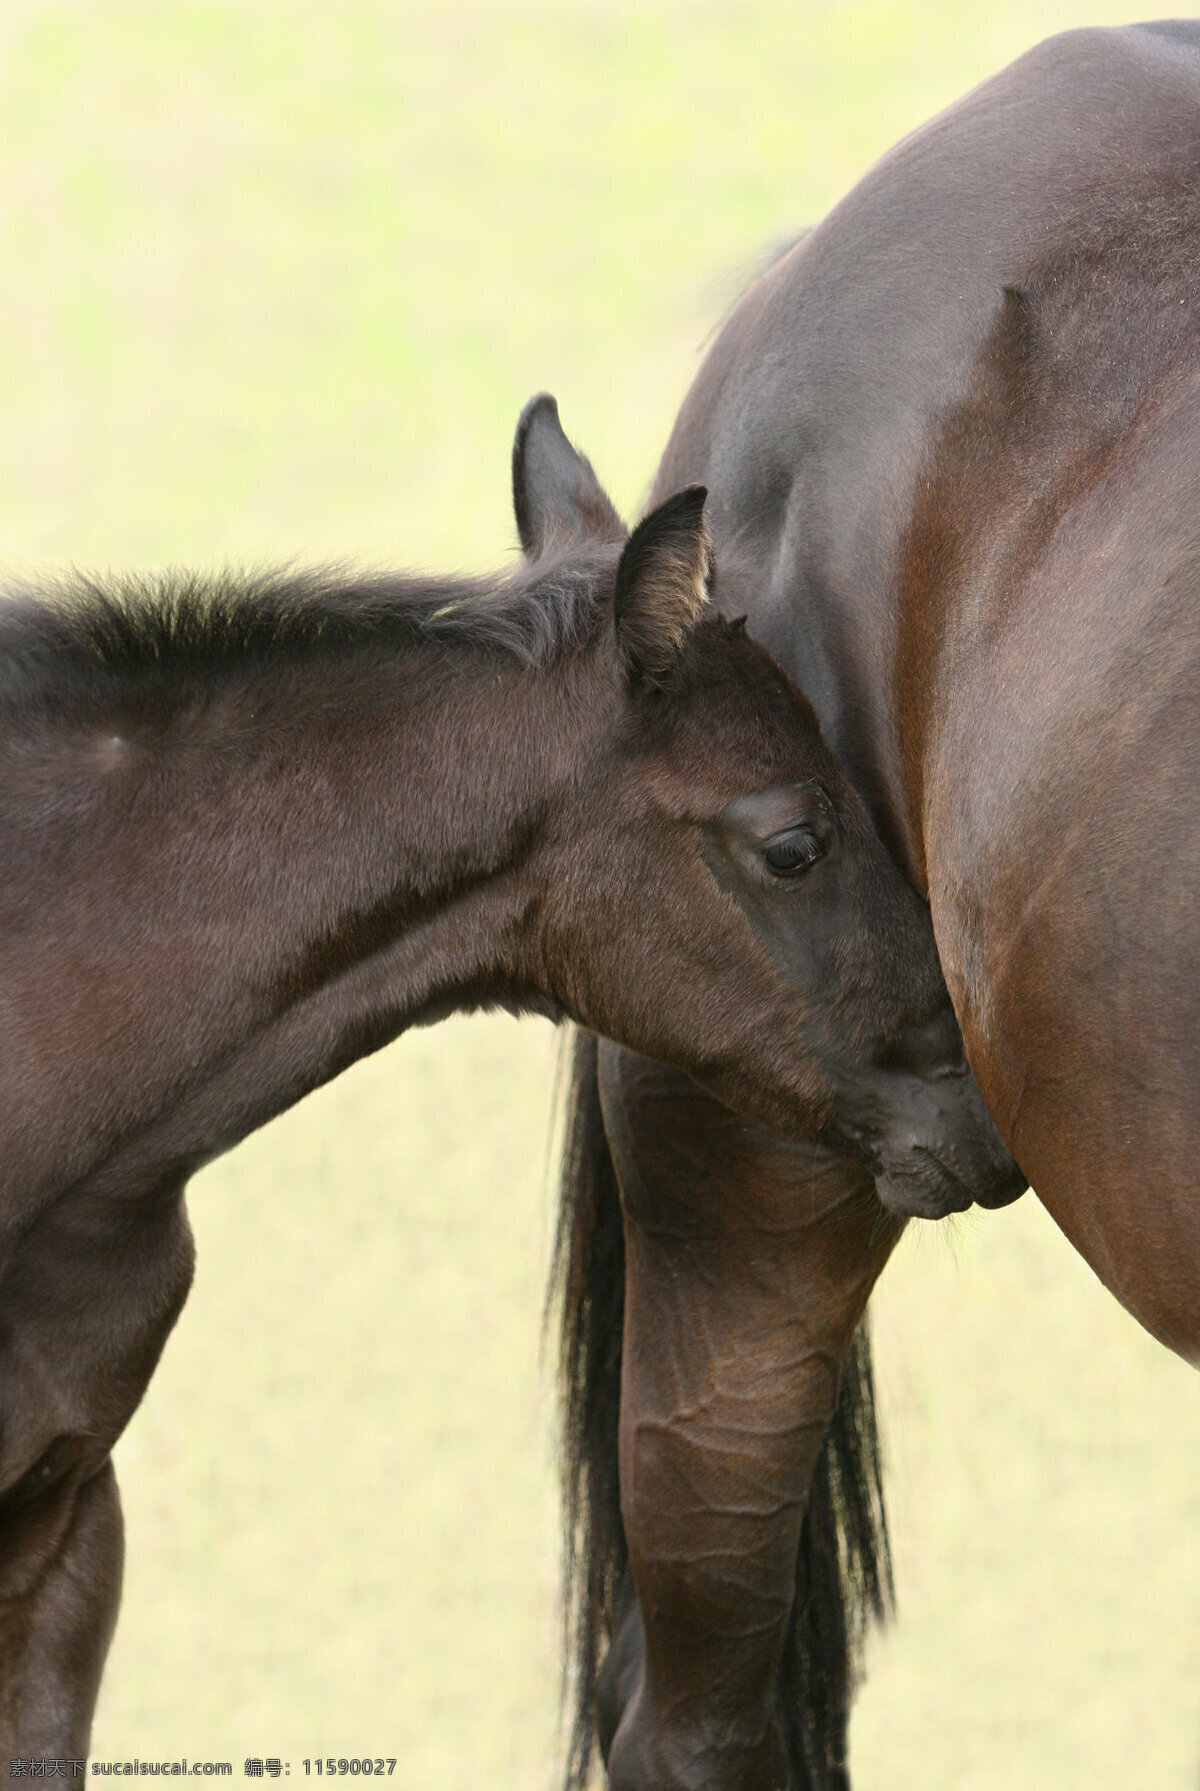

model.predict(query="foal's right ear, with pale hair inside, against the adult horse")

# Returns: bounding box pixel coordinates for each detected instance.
[613,485,713,684]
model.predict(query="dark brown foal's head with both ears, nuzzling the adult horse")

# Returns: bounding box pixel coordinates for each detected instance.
[512,396,1019,1216]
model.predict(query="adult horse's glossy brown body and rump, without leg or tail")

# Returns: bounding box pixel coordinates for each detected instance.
[657,21,1200,1356]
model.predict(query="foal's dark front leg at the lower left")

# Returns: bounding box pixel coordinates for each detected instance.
[0,1186,192,1761]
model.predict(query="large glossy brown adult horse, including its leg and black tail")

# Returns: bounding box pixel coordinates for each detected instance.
[559,23,1200,1791]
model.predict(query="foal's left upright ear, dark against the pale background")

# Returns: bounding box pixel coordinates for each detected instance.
[512,392,625,559]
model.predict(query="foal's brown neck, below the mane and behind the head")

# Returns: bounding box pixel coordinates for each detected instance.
[0,565,614,1191]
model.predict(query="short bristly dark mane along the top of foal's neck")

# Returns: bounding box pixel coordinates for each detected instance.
[0,550,613,707]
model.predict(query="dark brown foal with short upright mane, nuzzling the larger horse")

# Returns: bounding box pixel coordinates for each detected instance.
[0,399,992,1757]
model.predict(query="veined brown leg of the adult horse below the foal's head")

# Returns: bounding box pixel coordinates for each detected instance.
[600,1048,899,1791]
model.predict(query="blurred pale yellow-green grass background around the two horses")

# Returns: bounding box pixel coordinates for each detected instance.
[0,0,1200,1791]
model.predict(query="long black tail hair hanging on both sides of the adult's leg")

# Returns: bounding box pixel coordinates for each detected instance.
[550,1033,892,1791]
